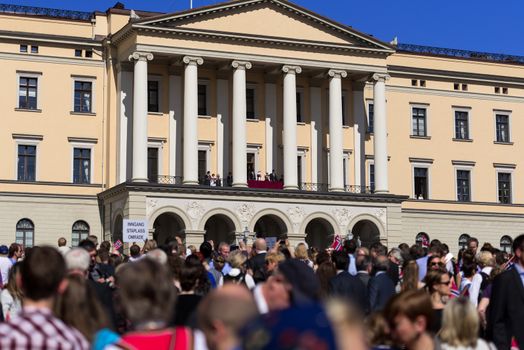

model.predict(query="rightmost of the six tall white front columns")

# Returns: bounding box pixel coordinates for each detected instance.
[373,74,389,193]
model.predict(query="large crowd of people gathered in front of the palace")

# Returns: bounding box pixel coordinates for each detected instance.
[0,235,524,350]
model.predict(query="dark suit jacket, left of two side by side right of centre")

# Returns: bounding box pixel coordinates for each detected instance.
[329,271,368,313]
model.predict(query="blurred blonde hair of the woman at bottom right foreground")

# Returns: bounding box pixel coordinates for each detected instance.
[440,297,479,348]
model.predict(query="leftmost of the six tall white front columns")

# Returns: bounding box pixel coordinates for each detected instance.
[129,52,153,182]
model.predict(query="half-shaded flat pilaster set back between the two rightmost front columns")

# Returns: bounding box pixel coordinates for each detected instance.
[353,82,367,186]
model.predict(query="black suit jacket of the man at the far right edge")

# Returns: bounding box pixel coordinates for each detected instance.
[488,268,524,350]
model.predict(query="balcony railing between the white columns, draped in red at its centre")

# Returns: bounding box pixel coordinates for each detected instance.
[149,175,374,194]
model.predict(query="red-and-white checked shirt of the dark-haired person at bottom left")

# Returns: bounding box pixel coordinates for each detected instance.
[0,308,89,350]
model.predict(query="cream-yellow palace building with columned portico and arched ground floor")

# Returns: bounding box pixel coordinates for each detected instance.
[0,0,524,252]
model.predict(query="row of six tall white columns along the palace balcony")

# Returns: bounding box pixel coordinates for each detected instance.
[129,52,388,193]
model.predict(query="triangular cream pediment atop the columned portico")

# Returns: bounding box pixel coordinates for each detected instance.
[134,0,392,51]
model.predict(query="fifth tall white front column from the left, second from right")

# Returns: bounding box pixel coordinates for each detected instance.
[328,69,347,192]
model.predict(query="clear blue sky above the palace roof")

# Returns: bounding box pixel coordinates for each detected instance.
[4,0,524,56]
